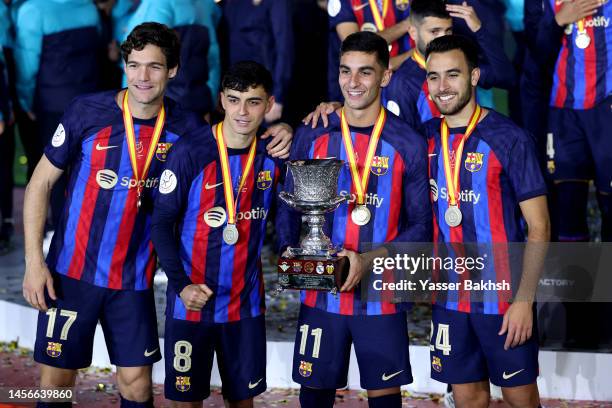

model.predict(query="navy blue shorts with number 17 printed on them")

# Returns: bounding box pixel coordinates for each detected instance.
[34,273,161,369]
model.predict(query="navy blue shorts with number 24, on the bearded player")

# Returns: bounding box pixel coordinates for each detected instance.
[430,305,538,387]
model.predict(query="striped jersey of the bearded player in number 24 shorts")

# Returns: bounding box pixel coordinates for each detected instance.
[426,110,546,314]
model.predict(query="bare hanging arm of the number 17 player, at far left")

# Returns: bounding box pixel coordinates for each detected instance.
[23,155,64,310]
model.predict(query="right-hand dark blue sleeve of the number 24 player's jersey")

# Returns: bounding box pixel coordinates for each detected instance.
[508,131,546,202]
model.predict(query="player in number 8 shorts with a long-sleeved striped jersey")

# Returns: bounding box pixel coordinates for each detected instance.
[152,61,283,408]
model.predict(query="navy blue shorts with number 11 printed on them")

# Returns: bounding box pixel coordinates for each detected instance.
[293,305,412,390]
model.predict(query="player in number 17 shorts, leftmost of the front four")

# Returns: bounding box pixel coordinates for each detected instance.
[23,23,201,407]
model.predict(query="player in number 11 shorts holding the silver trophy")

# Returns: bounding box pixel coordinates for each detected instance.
[279,32,431,408]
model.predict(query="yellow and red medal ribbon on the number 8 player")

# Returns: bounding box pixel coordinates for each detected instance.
[214,122,257,224]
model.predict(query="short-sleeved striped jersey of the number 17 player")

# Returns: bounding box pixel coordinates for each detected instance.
[45,91,199,290]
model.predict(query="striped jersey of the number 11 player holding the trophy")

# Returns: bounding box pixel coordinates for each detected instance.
[279,108,431,315]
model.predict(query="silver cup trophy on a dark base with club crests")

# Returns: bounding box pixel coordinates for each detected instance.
[278,159,348,293]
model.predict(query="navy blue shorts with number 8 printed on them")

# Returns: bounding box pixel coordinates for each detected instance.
[164,315,267,402]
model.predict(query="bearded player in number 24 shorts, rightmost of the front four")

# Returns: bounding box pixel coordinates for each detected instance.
[425,35,550,408]
